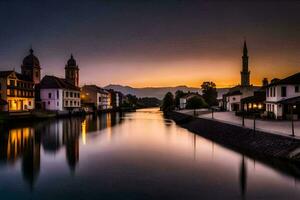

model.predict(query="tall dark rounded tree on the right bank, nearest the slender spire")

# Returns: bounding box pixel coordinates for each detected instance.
[201,82,218,106]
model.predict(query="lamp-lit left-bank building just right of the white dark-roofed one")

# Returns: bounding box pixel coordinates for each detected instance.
[81,85,111,111]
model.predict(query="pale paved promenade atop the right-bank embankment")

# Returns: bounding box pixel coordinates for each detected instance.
[179,109,300,139]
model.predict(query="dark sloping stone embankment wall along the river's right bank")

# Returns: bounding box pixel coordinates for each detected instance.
[165,112,300,164]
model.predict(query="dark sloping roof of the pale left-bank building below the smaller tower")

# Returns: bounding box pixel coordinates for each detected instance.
[40,76,80,91]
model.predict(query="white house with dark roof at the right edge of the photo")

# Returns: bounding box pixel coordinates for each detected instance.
[266,72,300,119]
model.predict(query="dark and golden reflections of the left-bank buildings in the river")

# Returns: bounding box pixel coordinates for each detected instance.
[0,113,121,190]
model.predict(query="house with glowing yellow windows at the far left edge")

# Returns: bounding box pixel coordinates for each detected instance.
[0,71,35,112]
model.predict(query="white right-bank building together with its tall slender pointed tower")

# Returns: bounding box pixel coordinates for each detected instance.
[221,41,260,111]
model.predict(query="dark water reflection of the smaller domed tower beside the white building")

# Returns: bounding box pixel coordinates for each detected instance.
[63,118,81,172]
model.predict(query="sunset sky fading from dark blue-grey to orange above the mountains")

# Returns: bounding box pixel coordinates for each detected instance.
[0,0,300,87]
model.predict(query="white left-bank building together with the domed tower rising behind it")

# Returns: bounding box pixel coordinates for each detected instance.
[39,55,81,113]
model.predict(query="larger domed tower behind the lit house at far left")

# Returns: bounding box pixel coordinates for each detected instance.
[21,48,41,84]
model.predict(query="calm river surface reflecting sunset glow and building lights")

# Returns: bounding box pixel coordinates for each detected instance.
[0,109,300,200]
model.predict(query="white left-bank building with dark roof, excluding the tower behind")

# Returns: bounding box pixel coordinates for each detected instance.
[40,76,81,112]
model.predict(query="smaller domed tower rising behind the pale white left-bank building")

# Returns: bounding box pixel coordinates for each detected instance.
[65,54,79,87]
